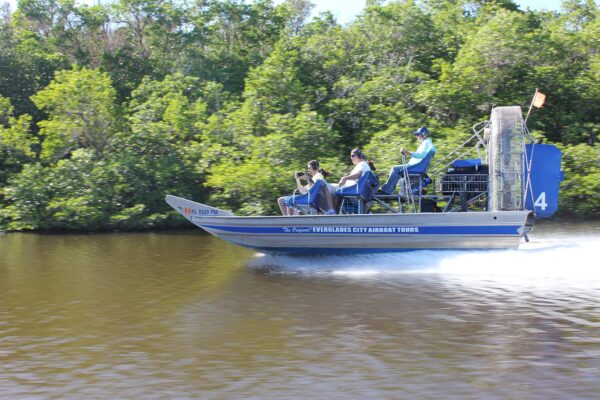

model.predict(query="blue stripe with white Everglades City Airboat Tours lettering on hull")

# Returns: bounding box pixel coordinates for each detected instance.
[201,225,521,235]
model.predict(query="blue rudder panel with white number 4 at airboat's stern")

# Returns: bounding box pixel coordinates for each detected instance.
[525,144,564,218]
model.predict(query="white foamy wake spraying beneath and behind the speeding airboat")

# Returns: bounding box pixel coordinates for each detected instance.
[249,236,600,285]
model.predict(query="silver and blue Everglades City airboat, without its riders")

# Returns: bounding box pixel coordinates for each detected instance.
[165,106,562,254]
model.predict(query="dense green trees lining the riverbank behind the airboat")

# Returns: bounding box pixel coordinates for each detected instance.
[0,0,600,230]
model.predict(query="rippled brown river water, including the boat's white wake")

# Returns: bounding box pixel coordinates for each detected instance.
[0,224,600,399]
